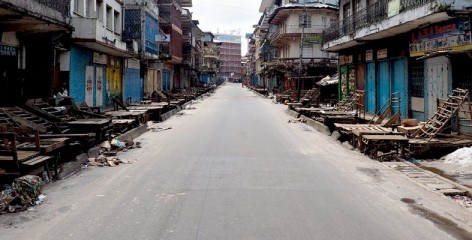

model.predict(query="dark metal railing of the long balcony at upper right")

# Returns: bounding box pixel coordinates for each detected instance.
[323,0,435,42]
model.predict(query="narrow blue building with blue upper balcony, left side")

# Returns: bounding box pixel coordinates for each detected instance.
[123,0,161,102]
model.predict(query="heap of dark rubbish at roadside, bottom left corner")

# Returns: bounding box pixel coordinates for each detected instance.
[0,175,46,213]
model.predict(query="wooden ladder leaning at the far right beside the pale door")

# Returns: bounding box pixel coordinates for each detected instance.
[414,88,469,141]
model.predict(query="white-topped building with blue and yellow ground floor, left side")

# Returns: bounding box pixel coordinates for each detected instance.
[67,0,132,107]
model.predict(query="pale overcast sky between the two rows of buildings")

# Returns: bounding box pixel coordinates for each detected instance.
[190,0,262,55]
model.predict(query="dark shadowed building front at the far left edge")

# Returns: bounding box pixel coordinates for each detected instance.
[0,0,73,106]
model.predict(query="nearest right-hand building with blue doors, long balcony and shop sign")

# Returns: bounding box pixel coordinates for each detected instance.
[323,0,472,120]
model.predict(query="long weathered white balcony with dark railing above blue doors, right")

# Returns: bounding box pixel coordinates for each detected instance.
[323,0,456,51]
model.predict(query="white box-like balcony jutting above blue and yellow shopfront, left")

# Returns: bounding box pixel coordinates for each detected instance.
[72,17,130,57]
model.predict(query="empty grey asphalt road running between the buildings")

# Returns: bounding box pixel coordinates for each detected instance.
[0,84,472,240]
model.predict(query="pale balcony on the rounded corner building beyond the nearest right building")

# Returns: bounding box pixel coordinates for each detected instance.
[270,25,326,47]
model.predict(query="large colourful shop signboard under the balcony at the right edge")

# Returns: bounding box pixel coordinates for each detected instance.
[410,19,472,57]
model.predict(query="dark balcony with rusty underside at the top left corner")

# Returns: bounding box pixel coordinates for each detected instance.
[0,0,73,33]
